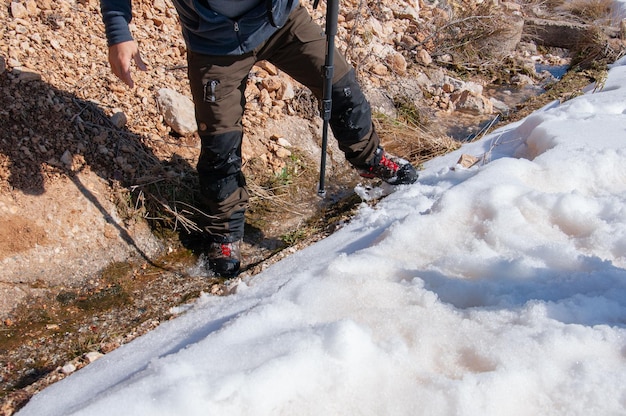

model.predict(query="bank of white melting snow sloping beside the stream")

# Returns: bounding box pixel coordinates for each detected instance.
[19,39,626,416]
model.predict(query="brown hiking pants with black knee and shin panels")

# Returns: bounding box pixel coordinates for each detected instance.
[188,6,379,242]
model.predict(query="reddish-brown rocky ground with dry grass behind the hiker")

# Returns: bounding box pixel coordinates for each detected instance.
[0,0,624,414]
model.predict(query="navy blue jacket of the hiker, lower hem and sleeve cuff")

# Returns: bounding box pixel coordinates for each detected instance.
[100,0,299,55]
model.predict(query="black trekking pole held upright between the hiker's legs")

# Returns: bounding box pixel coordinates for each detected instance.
[313,0,339,198]
